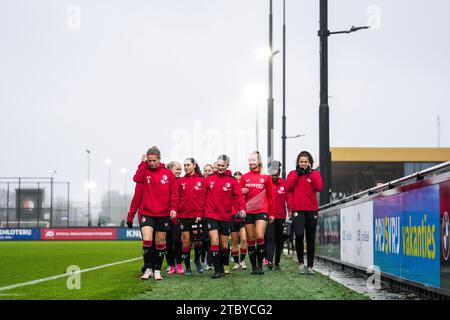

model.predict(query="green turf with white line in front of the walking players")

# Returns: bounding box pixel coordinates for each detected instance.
[0,241,369,300]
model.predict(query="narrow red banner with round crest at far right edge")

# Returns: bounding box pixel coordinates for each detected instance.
[439,181,450,289]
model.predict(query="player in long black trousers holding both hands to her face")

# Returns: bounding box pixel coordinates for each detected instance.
[286,151,323,274]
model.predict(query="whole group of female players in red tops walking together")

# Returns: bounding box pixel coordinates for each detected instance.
[127,147,322,280]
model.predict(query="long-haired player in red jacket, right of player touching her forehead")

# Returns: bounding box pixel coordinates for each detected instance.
[177,158,206,276]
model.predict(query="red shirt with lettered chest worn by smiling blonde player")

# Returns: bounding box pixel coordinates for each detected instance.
[241,171,274,217]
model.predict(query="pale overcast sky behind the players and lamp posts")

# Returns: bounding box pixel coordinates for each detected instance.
[0,0,450,205]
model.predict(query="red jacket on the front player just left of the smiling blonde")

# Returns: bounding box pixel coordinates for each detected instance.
[205,170,246,221]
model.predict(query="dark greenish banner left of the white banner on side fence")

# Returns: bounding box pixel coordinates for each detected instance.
[316,209,341,260]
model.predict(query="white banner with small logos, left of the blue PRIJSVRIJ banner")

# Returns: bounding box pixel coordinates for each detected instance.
[341,201,373,268]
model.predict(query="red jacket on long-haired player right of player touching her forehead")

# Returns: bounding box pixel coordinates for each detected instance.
[177,173,207,218]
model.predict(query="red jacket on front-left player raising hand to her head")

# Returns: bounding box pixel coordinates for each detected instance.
[133,161,178,217]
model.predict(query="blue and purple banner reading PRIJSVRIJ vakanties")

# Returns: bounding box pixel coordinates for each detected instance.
[373,185,440,287]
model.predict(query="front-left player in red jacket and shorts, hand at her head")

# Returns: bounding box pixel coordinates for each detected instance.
[133,147,178,280]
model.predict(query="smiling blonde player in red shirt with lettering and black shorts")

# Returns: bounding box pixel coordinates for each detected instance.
[241,151,275,274]
